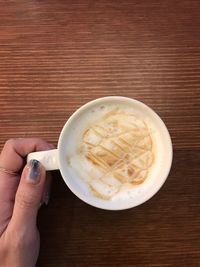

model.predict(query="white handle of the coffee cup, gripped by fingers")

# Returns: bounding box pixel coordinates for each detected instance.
[27,149,59,171]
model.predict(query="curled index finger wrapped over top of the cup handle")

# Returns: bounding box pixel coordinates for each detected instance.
[0,138,53,172]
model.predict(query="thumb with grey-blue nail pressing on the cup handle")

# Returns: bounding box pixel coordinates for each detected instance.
[11,159,45,229]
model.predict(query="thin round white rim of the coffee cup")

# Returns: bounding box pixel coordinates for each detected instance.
[58,96,173,210]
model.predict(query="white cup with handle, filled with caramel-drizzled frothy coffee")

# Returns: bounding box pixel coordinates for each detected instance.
[28,96,172,210]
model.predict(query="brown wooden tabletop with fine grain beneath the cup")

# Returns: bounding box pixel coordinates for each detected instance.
[0,0,200,267]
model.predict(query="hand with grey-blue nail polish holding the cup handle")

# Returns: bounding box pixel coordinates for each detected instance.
[0,138,53,267]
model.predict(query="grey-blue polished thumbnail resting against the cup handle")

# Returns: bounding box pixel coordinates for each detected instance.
[27,159,41,184]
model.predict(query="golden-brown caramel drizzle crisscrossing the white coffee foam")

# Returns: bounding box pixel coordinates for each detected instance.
[80,111,154,198]
